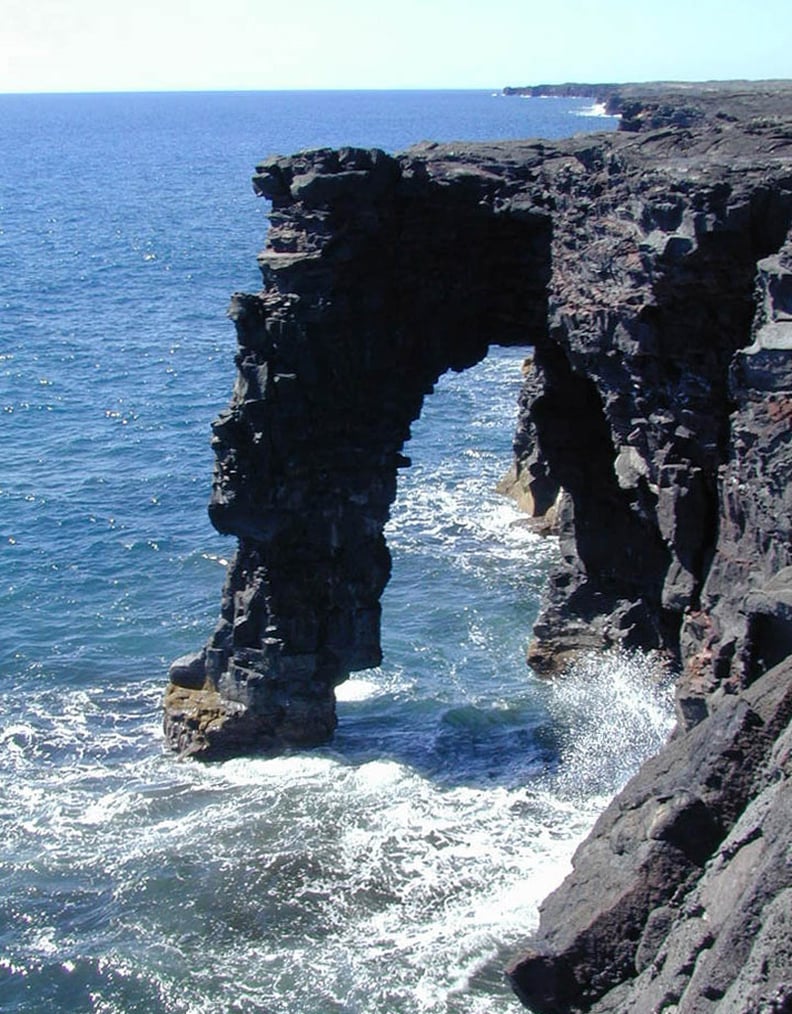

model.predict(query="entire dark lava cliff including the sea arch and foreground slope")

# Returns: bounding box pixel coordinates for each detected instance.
[160,86,792,1014]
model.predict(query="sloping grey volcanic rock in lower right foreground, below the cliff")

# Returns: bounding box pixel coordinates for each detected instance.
[510,660,792,1014]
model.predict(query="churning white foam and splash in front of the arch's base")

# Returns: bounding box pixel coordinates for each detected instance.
[0,657,667,1014]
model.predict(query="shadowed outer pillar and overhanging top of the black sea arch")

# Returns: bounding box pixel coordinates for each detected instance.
[165,149,551,756]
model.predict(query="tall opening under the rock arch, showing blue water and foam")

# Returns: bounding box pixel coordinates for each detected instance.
[334,348,557,787]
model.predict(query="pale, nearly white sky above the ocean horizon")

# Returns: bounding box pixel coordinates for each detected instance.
[0,0,792,92]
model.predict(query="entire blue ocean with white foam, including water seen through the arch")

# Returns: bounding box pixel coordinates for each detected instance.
[0,92,669,1014]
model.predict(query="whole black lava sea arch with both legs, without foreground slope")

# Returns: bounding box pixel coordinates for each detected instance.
[165,113,791,756]
